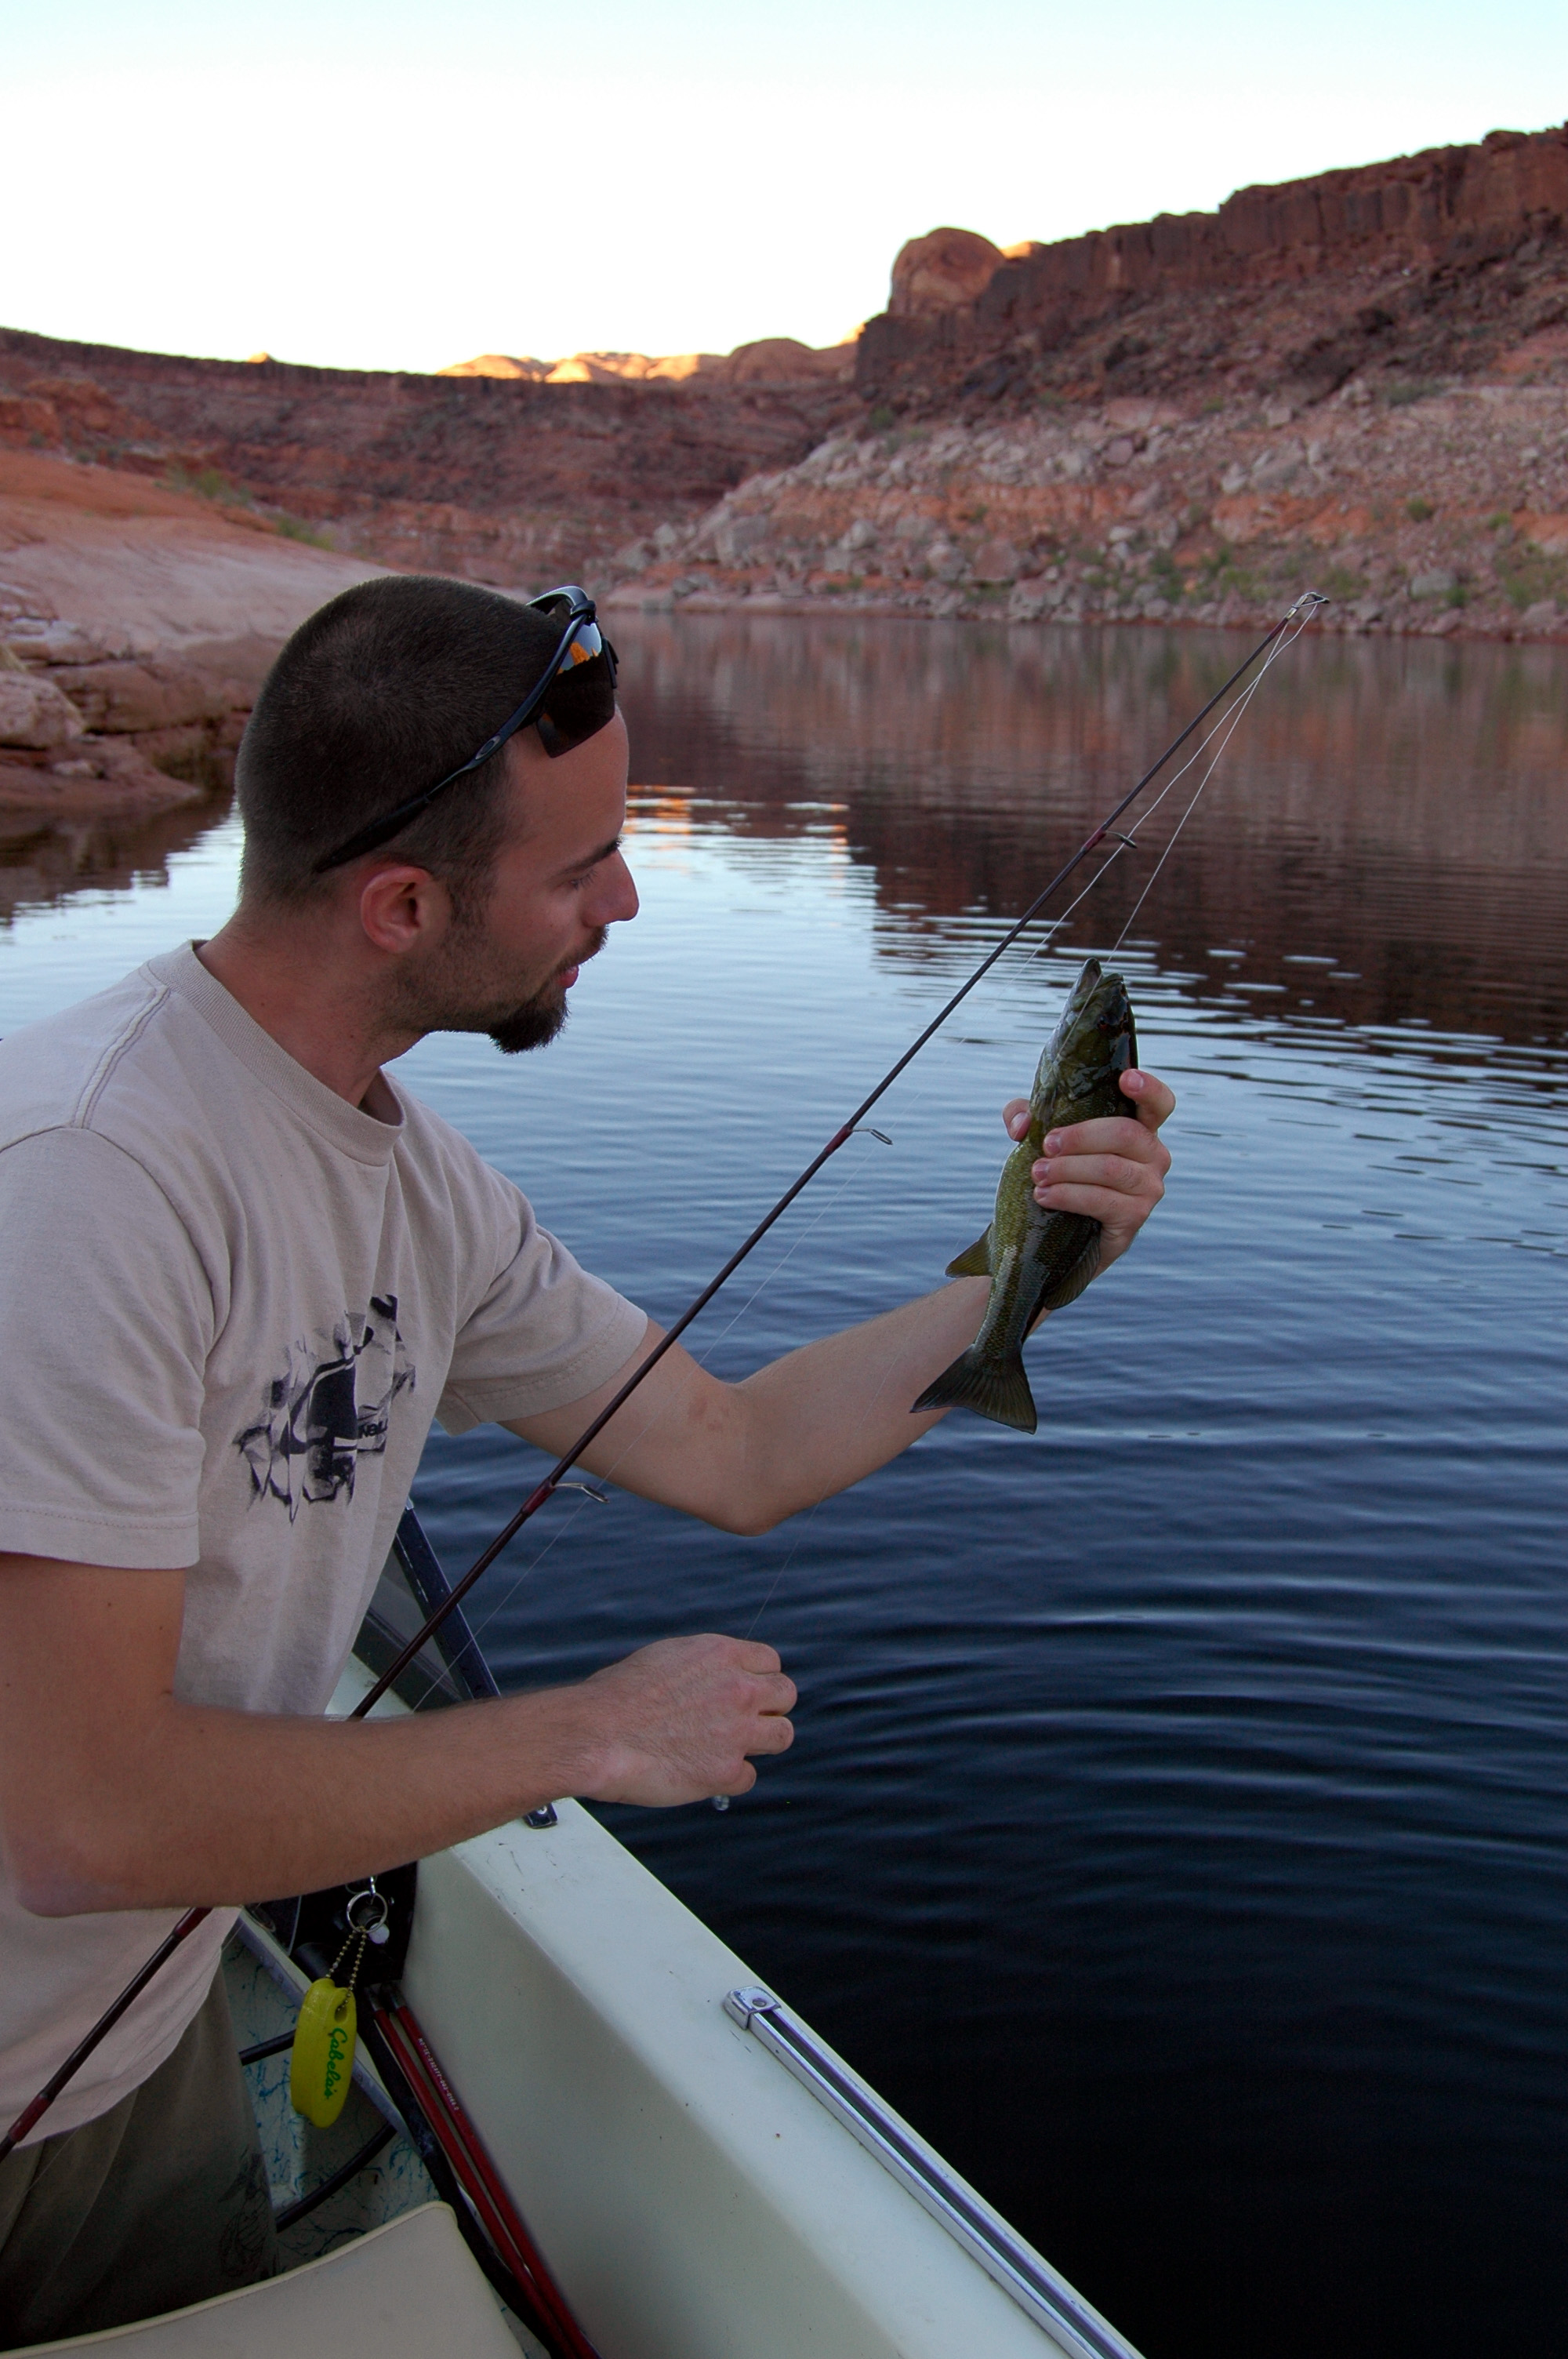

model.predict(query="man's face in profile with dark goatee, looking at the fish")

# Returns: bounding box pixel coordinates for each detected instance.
[419,714,637,1055]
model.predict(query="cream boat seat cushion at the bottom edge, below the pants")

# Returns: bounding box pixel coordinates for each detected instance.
[12,2203,519,2359]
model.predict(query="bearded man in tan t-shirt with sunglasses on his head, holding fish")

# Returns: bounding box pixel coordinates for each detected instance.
[0,578,1172,2345]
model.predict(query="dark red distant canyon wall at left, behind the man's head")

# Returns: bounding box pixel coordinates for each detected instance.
[0,330,856,590]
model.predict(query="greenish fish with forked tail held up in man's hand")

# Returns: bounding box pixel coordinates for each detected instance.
[910,958,1139,1434]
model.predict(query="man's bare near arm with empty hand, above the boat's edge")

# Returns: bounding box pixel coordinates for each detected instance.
[0,1554,795,1915]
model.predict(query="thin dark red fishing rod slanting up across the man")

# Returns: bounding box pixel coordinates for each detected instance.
[0,590,1330,2163]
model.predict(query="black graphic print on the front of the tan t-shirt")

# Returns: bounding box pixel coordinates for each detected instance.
[234,1295,415,1524]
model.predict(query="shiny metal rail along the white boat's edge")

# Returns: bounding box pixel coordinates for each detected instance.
[724,1989,1139,2359]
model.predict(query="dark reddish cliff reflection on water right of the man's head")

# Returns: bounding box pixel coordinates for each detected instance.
[618,616,1568,1043]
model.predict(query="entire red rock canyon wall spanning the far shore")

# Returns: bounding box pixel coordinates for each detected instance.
[0,129,1568,651]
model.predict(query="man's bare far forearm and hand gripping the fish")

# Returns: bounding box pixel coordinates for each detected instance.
[512,1074,1174,1533]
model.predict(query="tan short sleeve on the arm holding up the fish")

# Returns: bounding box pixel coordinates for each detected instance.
[436,1165,648,1434]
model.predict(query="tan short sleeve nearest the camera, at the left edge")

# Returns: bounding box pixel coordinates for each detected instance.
[0,1128,215,1568]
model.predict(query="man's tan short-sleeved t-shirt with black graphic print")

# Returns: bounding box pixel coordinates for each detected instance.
[0,946,646,2137]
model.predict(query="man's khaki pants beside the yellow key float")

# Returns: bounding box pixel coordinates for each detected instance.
[0,1972,278,2350]
